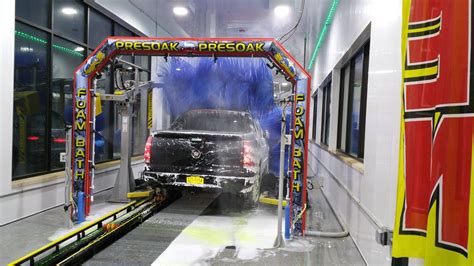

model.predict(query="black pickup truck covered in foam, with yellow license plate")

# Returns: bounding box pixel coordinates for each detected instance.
[143,109,269,206]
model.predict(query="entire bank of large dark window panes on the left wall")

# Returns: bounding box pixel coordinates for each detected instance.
[12,0,151,179]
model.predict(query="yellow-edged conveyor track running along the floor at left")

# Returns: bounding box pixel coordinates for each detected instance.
[9,190,176,265]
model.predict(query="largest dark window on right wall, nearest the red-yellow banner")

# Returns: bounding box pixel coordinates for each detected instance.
[337,43,370,159]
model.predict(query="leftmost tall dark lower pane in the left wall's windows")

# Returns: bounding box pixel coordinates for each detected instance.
[12,22,49,176]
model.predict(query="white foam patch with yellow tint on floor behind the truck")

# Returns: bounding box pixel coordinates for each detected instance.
[152,209,277,265]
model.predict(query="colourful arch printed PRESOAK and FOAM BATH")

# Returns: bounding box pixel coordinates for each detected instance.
[71,37,311,235]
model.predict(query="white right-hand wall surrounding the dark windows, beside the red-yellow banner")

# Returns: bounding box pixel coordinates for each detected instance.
[309,0,402,265]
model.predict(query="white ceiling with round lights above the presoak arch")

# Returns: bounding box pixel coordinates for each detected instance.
[129,0,312,64]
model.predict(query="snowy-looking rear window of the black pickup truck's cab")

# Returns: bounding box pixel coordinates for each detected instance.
[171,110,253,133]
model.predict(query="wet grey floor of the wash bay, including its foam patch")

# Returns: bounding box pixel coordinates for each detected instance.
[0,183,365,266]
